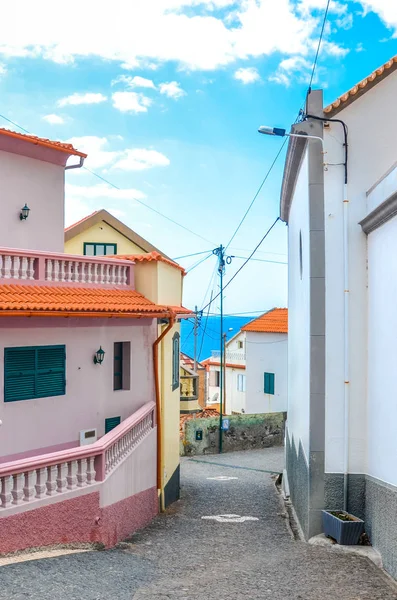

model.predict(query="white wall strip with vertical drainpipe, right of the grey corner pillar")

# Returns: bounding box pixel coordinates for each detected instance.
[324,73,397,473]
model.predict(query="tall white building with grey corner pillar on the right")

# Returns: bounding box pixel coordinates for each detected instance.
[281,56,397,577]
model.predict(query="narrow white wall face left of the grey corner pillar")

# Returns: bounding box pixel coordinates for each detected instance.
[288,154,310,458]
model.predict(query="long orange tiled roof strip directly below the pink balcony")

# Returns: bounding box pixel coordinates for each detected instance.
[0,285,172,318]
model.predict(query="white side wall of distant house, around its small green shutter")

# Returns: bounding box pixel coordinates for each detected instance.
[246,331,288,414]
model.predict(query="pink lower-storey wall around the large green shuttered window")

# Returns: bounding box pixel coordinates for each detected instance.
[0,317,157,457]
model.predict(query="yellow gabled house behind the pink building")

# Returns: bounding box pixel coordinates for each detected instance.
[65,209,186,509]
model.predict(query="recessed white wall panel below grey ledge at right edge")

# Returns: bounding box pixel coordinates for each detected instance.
[368,217,397,485]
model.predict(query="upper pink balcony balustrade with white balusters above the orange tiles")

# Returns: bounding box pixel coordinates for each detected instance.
[0,248,134,289]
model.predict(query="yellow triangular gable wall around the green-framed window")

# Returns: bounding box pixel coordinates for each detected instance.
[65,221,144,254]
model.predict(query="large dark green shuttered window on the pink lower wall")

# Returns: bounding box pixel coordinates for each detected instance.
[4,346,66,402]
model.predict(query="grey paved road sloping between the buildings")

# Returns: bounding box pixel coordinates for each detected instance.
[0,449,397,600]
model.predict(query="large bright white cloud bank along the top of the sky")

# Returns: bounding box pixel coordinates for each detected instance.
[0,0,346,70]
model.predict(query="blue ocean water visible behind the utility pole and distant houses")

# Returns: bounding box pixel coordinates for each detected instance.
[181,316,254,360]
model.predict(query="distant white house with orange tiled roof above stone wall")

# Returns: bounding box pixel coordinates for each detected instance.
[204,308,288,414]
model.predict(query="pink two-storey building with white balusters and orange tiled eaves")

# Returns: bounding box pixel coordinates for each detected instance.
[0,129,182,552]
